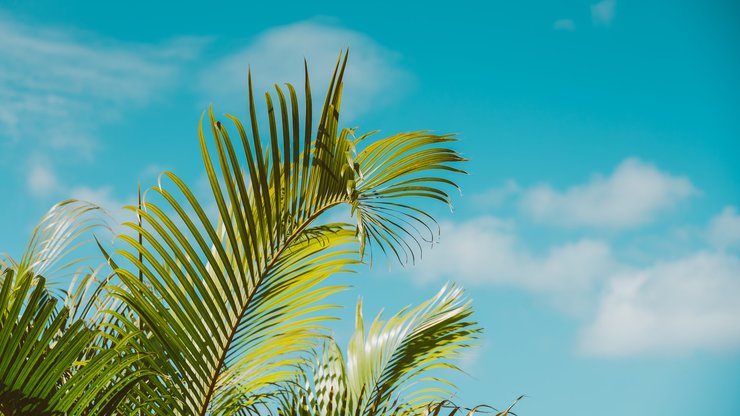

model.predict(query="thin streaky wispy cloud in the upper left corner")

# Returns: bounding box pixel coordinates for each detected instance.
[0,10,207,224]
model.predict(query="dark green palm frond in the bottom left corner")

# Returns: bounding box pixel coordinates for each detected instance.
[0,269,147,415]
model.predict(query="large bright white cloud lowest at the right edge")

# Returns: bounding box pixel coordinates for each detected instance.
[580,252,740,356]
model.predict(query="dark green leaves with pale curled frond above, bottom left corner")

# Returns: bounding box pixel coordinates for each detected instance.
[0,202,153,415]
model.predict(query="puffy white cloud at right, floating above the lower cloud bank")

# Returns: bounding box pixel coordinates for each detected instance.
[520,158,697,228]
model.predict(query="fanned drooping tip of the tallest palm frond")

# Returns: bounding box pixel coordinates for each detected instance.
[350,131,465,263]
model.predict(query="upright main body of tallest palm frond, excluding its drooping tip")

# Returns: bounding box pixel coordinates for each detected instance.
[107,53,355,415]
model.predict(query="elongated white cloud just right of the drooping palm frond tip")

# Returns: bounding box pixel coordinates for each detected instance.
[409,216,619,311]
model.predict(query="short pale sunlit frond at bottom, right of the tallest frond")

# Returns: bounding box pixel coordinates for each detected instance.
[278,287,480,416]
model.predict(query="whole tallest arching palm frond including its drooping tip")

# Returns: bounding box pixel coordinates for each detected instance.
[111,55,462,415]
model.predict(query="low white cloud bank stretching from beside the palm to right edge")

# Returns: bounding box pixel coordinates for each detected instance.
[406,210,740,357]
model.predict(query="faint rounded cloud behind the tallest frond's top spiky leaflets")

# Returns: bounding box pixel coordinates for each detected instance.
[201,21,411,118]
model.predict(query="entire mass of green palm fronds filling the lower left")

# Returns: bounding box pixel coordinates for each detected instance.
[0,55,516,416]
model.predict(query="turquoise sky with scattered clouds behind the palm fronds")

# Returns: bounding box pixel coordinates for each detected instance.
[0,0,740,416]
